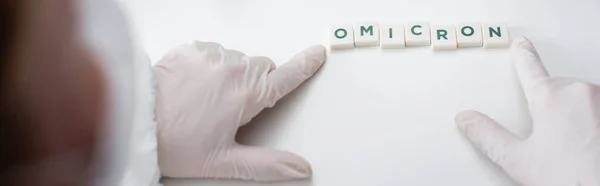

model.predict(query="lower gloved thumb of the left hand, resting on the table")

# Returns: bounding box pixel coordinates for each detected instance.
[205,145,312,181]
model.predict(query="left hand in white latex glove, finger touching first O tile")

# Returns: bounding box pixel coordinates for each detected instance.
[154,42,326,181]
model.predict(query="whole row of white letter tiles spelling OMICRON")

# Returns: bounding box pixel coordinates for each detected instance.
[329,22,509,50]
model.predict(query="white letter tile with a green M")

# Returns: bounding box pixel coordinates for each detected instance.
[354,22,379,47]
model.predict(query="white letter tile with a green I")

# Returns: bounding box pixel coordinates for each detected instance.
[379,24,406,48]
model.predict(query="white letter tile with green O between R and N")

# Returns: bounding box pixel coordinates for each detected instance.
[456,23,483,47]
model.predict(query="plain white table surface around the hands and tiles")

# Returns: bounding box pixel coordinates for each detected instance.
[122,0,600,186]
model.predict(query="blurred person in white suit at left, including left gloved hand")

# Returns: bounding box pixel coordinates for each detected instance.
[0,0,325,186]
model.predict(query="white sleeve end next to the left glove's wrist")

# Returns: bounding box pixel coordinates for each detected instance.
[120,47,161,186]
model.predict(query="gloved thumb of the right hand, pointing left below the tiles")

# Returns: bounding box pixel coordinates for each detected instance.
[455,110,521,170]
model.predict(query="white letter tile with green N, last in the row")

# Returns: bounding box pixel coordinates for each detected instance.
[481,24,510,48]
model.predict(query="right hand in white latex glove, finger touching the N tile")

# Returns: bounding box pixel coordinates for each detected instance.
[456,38,600,186]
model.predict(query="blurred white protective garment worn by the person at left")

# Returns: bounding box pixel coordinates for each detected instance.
[79,0,160,186]
